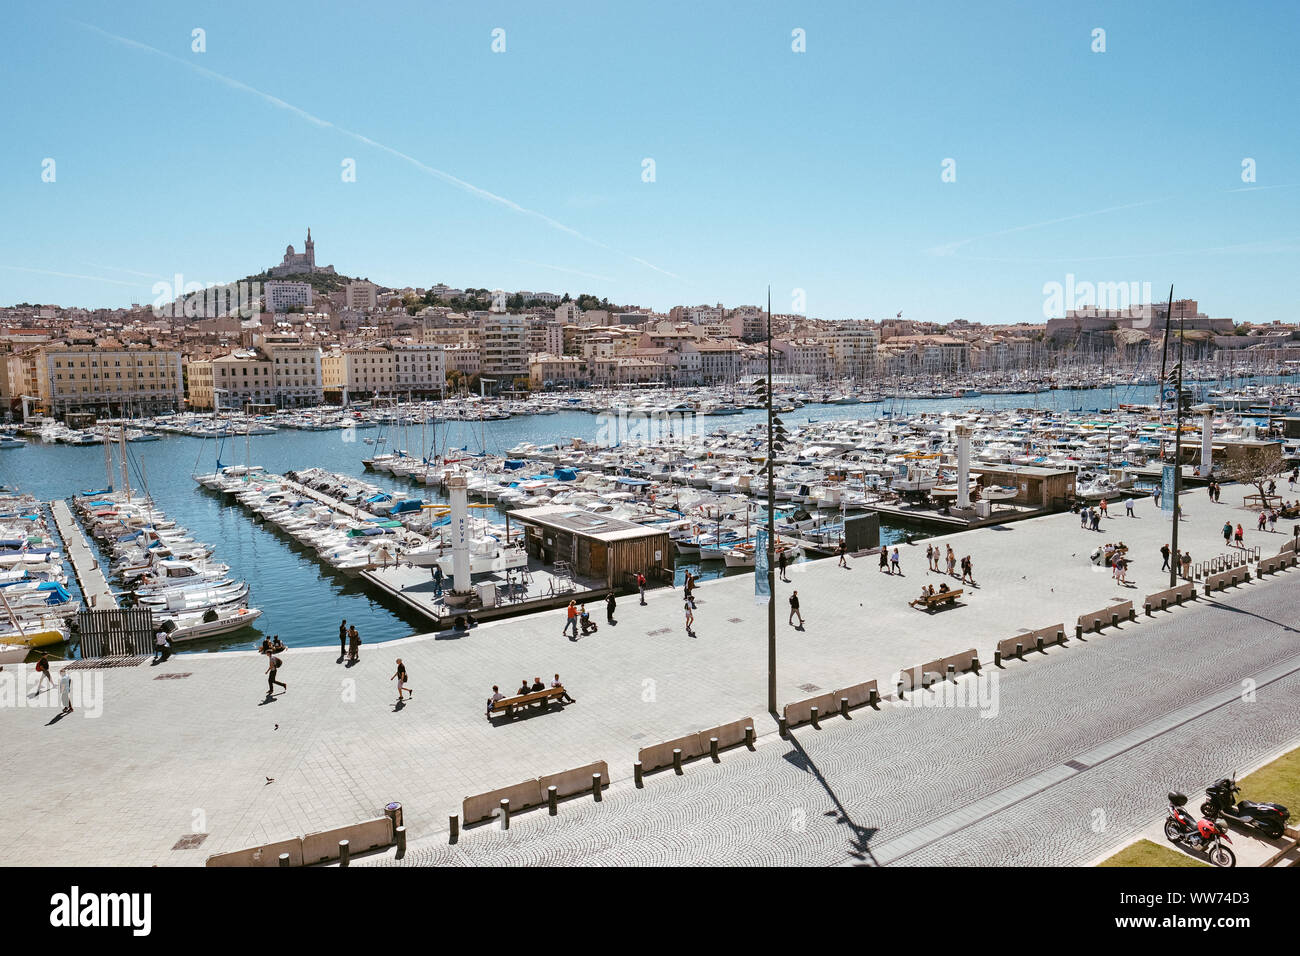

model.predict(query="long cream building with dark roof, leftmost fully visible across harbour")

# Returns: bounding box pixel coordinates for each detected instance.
[33,343,185,415]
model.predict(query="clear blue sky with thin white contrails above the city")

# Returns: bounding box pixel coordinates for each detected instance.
[0,0,1300,323]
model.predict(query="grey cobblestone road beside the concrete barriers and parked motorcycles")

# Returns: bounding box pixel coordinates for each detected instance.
[360,587,1300,866]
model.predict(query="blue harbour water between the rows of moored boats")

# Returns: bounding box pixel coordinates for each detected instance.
[0,380,1289,652]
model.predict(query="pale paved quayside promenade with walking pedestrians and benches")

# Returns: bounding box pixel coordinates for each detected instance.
[0,489,1300,865]
